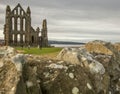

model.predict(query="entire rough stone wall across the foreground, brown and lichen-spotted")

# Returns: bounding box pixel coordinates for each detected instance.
[0,41,120,94]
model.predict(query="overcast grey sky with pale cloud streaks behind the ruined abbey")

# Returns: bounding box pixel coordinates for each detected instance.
[0,0,120,42]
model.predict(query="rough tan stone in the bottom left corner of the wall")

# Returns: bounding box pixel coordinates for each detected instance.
[0,60,22,94]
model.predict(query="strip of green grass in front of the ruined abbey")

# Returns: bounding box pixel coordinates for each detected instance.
[15,47,62,55]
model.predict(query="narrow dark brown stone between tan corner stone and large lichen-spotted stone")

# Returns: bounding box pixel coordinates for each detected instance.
[23,64,42,94]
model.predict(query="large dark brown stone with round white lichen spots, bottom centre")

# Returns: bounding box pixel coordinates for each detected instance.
[29,61,96,94]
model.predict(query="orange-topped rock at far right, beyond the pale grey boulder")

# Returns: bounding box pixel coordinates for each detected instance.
[85,41,120,94]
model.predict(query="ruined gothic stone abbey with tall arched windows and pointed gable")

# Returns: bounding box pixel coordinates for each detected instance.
[4,4,48,47]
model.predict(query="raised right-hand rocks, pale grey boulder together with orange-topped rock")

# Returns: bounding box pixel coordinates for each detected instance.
[57,41,120,94]
